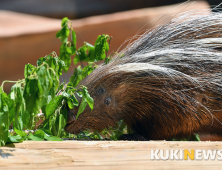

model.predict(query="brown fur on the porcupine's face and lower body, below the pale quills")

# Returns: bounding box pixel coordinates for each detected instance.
[66,70,222,140]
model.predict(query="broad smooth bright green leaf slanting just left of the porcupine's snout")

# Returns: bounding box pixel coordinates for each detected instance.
[46,95,64,119]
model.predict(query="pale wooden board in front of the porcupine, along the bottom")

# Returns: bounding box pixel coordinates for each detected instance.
[0,141,222,170]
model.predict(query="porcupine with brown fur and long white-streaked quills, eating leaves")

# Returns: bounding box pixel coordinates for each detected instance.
[65,8,222,140]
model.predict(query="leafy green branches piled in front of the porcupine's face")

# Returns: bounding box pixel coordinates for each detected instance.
[0,17,114,146]
